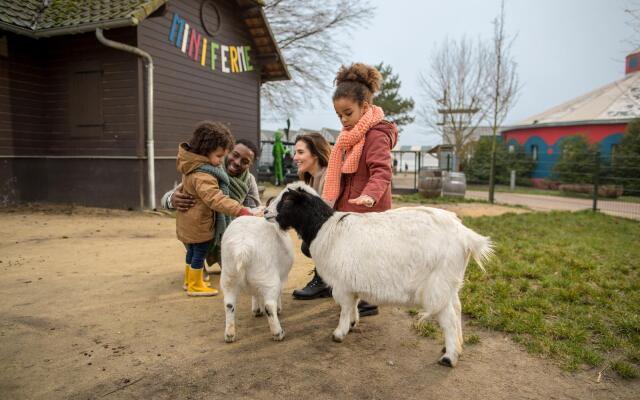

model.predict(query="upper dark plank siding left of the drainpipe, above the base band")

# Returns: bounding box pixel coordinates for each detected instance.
[0,28,143,156]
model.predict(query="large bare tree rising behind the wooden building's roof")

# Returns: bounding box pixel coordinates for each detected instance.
[261,0,374,115]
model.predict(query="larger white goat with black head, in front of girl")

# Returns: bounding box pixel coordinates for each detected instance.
[265,183,492,367]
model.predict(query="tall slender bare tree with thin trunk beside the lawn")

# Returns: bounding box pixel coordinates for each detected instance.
[486,0,520,203]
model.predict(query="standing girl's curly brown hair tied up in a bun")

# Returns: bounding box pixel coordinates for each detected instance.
[333,63,382,104]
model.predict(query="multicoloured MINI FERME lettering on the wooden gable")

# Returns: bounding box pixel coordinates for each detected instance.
[169,14,253,73]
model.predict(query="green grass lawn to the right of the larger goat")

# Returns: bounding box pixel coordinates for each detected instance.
[452,212,640,378]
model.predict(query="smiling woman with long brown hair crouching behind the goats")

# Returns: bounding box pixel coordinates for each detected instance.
[293,133,331,300]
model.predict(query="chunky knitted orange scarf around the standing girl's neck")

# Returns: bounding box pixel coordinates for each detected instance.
[322,105,384,202]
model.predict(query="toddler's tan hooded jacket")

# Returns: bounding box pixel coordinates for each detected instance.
[176,143,243,243]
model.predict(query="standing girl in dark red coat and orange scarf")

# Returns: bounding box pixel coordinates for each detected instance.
[322,63,398,317]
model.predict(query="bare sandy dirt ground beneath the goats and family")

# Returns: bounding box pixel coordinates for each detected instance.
[0,204,640,400]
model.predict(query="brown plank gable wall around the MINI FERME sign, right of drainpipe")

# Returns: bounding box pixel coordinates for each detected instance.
[138,0,260,196]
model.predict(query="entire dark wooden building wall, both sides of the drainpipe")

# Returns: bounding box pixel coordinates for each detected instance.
[0,0,260,208]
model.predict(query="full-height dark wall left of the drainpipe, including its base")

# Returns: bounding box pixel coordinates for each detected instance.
[0,28,145,208]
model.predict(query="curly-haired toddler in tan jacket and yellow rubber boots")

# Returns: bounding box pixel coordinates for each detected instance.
[176,121,251,296]
